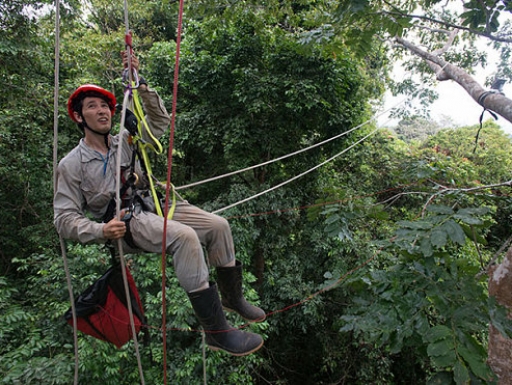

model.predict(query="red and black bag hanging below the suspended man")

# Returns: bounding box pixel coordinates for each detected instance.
[64,264,147,348]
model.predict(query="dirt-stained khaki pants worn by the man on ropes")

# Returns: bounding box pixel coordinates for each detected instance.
[123,201,235,293]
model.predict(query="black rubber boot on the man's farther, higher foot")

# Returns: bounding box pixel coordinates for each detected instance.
[217,261,266,322]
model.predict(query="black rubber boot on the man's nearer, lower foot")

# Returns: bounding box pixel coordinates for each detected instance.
[188,283,263,356]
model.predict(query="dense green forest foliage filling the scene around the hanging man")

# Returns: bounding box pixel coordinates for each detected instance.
[0,0,512,384]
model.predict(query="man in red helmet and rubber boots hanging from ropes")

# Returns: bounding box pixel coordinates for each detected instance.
[54,53,265,356]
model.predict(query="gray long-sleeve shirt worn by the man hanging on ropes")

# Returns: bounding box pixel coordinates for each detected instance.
[53,89,171,243]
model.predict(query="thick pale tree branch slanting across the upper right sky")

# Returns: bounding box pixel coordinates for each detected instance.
[395,37,512,123]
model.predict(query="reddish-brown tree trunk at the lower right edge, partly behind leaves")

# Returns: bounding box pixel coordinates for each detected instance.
[488,248,512,385]
